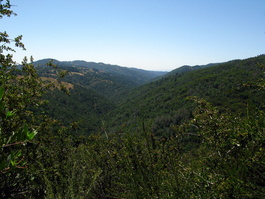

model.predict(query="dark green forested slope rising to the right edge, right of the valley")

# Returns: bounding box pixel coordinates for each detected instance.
[108,55,265,131]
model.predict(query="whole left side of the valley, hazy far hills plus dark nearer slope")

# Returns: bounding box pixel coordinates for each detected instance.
[33,59,165,134]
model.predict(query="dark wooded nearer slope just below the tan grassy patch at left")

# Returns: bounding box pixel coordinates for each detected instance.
[43,85,114,134]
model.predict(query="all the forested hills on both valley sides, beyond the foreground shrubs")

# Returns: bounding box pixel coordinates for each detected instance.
[32,55,265,134]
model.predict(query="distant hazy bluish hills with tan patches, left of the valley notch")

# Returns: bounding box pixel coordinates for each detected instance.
[33,59,166,99]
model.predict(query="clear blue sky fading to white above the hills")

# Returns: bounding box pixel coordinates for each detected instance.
[0,0,265,71]
